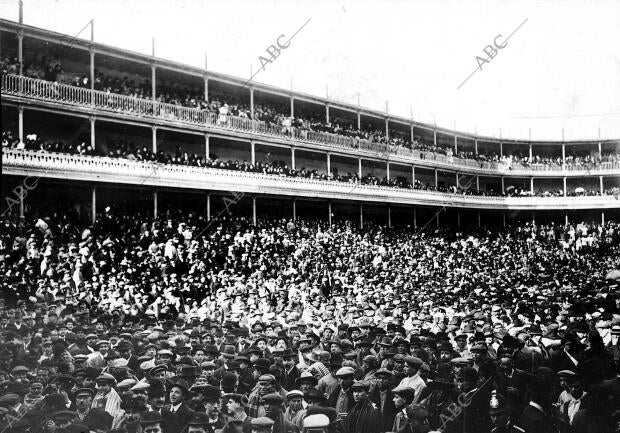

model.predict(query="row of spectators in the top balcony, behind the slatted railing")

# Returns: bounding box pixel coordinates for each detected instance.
[0,55,620,170]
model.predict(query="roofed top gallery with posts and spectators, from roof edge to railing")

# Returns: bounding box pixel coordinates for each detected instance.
[0,20,620,176]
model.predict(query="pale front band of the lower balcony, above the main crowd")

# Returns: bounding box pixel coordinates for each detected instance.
[2,149,620,210]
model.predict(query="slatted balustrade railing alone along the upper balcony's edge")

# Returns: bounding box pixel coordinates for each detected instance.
[2,74,620,176]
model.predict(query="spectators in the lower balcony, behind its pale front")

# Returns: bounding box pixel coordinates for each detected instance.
[2,131,620,197]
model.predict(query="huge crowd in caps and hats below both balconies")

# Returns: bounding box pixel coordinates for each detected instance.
[0,203,620,433]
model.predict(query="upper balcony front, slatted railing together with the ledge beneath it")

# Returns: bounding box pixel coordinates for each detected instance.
[2,74,620,177]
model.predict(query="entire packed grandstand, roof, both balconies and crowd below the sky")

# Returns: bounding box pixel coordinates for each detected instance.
[0,15,620,433]
